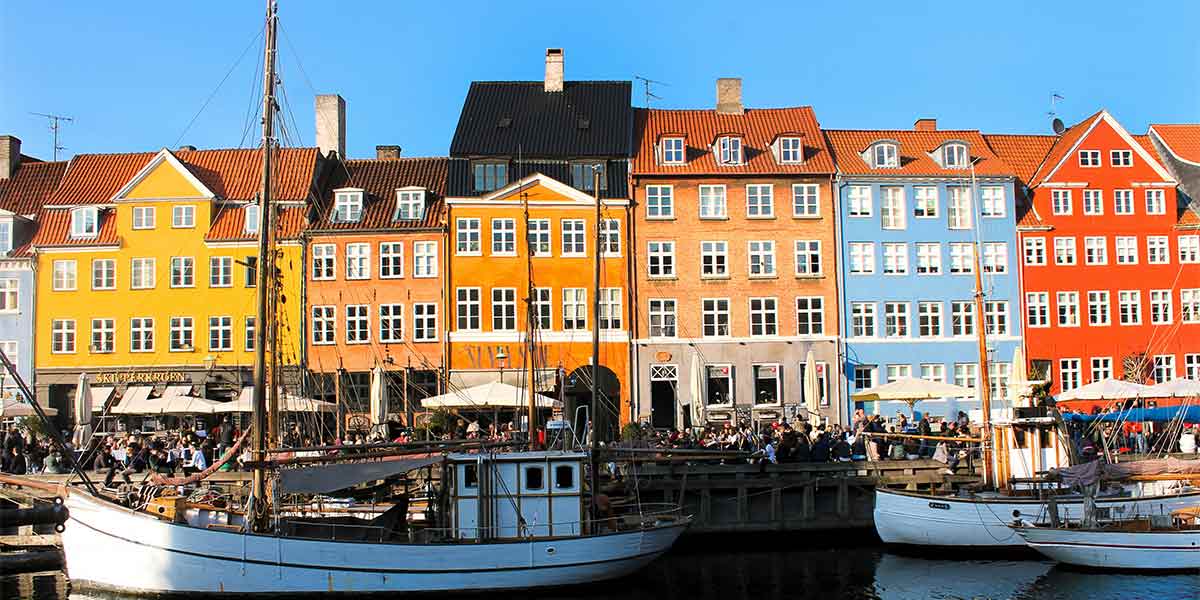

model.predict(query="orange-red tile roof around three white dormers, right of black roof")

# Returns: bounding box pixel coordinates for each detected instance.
[634,107,834,175]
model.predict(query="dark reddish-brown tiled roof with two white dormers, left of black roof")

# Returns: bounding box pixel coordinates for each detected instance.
[310,157,449,232]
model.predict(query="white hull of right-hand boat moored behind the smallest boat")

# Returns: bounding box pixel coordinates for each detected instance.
[875,488,1200,548]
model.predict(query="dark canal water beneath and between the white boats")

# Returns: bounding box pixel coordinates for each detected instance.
[0,534,1200,600]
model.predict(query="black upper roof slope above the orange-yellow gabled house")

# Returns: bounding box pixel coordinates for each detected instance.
[450,82,634,158]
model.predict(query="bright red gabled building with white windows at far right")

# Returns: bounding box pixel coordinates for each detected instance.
[989,110,1200,403]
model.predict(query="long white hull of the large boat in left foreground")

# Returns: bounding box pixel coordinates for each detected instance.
[62,492,686,594]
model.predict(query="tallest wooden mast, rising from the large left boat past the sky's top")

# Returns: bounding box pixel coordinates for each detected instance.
[246,0,277,532]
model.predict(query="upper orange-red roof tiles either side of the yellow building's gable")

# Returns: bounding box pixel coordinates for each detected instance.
[47,148,318,205]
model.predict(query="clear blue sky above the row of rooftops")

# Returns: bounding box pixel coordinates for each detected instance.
[0,0,1200,158]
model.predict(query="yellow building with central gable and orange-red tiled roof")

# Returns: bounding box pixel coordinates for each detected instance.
[34,144,319,422]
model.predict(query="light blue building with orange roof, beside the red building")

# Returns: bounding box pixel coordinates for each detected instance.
[826,120,1021,416]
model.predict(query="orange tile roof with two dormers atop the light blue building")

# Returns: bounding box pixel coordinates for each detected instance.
[826,130,1014,176]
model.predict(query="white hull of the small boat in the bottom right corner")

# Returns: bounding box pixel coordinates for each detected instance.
[1013,527,1200,571]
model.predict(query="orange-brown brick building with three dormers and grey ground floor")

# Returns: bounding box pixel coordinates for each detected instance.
[631,79,845,427]
